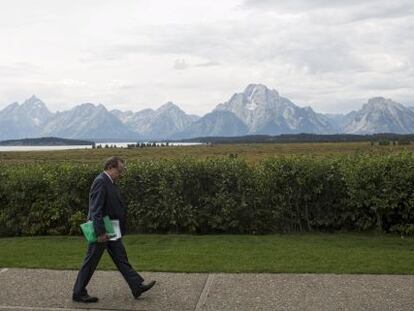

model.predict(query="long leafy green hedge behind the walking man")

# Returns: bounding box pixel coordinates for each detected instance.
[0,153,414,236]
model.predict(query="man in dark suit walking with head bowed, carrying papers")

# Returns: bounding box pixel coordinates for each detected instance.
[72,157,155,303]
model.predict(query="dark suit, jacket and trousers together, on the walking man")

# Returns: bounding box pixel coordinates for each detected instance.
[73,173,144,296]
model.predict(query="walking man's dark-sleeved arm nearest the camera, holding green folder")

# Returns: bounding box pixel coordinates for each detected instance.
[89,179,106,237]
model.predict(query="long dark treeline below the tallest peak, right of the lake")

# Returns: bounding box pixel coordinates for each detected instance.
[181,133,414,144]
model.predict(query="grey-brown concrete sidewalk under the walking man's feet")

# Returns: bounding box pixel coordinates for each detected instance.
[0,268,414,311]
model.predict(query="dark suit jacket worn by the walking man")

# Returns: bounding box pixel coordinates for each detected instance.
[88,172,126,236]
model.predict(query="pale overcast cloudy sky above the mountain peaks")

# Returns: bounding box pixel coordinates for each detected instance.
[0,0,414,115]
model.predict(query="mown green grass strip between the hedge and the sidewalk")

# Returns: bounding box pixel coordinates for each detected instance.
[0,233,414,274]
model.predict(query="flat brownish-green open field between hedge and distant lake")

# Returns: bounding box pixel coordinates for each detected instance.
[0,142,414,163]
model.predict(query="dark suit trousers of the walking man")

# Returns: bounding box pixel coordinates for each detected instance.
[73,238,144,297]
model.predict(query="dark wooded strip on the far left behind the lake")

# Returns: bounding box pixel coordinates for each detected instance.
[0,137,95,146]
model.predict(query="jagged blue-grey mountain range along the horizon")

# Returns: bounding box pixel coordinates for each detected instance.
[0,84,414,141]
